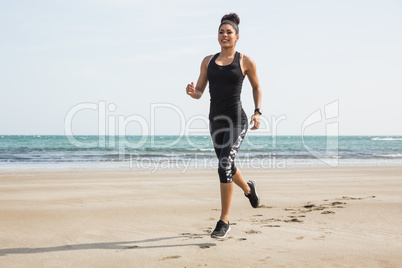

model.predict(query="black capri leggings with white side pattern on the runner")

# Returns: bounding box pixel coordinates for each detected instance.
[209,120,248,183]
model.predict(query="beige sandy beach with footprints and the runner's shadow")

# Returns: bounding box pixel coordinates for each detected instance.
[0,167,402,267]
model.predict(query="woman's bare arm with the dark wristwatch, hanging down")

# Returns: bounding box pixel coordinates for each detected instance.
[243,55,262,130]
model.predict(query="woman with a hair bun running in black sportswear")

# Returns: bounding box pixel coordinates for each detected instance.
[186,13,261,238]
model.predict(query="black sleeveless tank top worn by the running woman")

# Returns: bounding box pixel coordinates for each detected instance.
[207,52,247,123]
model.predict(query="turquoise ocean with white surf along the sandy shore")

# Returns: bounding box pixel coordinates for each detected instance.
[0,135,402,172]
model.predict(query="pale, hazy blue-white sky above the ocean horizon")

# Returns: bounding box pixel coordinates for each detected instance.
[0,0,402,136]
